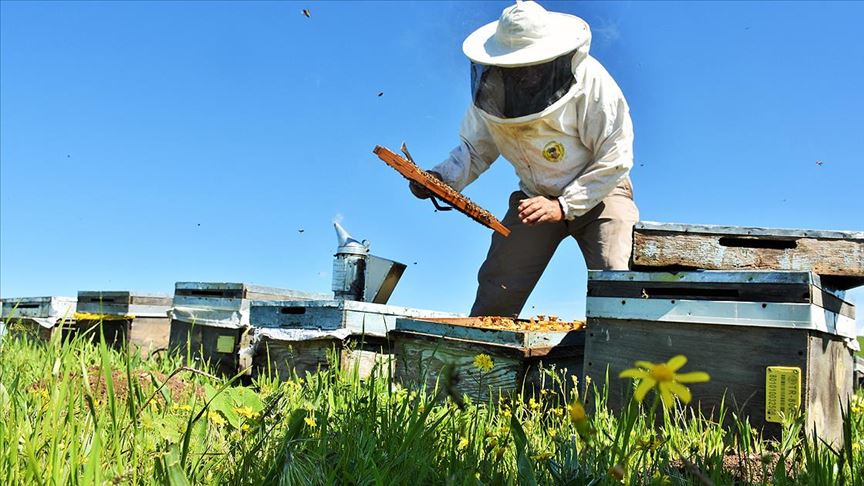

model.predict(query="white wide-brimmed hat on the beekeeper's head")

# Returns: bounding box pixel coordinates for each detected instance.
[462,1,591,67]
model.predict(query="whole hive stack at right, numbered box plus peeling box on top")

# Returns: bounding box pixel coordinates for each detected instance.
[585,223,864,443]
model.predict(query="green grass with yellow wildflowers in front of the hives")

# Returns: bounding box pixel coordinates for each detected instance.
[0,326,864,485]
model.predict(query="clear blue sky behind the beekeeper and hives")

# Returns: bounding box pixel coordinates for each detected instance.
[0,1,864,332]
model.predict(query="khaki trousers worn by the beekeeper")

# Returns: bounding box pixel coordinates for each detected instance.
[471,177,639,317]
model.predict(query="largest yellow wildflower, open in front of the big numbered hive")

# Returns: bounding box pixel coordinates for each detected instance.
[618,354,711,408]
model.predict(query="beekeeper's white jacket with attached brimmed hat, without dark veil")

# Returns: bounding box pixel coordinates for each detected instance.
[432,2,633,219]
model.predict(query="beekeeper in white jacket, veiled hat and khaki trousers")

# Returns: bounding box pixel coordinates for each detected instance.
[411,1,639,316]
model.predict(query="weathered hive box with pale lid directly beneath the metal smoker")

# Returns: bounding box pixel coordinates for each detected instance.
[250,299,456,378]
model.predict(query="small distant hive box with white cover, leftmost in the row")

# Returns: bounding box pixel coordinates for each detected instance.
[2,296,75,340]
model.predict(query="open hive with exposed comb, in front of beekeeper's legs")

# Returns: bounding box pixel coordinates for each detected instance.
[391,317,585,400]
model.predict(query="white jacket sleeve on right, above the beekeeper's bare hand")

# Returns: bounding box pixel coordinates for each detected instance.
[558,68,633,219]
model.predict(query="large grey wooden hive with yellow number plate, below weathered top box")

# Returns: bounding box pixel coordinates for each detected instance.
[585,271,857,442]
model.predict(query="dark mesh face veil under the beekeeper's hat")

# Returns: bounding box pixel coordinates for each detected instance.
[471,51,575,118]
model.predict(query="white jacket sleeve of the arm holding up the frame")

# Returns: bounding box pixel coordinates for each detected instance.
[432,106,500,192]
